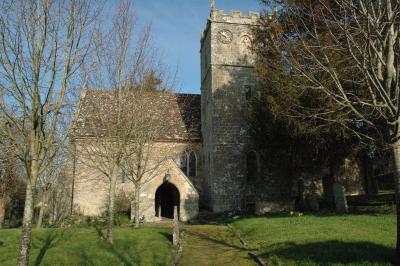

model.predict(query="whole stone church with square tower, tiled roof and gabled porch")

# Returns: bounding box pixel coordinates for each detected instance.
[73,3,293,221]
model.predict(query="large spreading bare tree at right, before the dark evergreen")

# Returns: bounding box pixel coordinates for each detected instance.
[256,0,400,259]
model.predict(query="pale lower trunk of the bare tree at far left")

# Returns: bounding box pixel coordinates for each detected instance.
[17,180,33,266]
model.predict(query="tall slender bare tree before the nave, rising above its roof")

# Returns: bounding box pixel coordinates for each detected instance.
[78,1,169,243]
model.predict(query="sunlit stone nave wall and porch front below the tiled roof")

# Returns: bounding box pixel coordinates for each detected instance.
[73,139,203,221]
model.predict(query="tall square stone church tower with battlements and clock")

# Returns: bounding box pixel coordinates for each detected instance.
[200,0,259,212]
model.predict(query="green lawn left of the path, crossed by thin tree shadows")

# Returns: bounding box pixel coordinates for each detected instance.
[0,227,173,266]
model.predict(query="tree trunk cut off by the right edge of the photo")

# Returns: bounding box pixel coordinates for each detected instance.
[393,140,400,265]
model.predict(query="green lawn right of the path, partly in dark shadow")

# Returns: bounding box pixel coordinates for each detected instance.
[232,214,396,265]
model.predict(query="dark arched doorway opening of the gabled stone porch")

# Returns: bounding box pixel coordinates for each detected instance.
[155,183,180,219]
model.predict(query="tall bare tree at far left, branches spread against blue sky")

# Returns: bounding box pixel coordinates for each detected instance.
[0,0,98,265]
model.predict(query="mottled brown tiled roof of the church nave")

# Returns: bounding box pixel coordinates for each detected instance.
[73,90,201,141]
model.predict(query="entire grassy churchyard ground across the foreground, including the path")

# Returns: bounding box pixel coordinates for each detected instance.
[0,214,396,266]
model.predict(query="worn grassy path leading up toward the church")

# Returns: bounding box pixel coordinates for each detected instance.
[179,225,256,266]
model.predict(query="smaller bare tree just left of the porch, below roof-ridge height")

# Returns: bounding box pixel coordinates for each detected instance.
[121,89,184,228]
